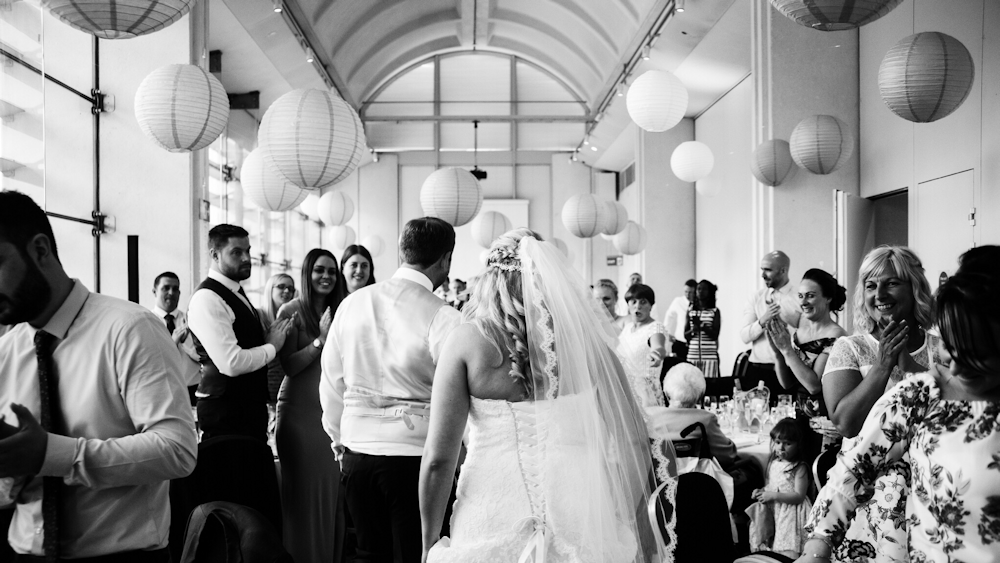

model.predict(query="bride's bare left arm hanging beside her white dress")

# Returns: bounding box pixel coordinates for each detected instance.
[419,326,470,558]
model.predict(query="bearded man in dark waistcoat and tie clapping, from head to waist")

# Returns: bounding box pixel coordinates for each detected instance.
[188,224,293,441]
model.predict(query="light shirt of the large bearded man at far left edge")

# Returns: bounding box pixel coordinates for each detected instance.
[0,280,197,558]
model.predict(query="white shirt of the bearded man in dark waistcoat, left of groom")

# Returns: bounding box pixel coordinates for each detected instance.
[188,270,277,377]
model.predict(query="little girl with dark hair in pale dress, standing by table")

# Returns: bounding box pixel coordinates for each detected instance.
[753,418,812,559]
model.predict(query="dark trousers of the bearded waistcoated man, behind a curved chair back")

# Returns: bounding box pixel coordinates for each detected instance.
[170,436,282,561]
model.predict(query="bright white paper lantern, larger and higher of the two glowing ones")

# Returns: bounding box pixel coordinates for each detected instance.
[625,70,688,133]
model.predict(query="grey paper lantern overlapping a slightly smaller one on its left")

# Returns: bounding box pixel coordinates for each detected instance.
[789,115,854,174]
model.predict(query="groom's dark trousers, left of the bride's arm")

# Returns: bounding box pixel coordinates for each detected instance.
[340,450,423,563]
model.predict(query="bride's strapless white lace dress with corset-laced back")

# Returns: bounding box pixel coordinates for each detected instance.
[427,396,637,563]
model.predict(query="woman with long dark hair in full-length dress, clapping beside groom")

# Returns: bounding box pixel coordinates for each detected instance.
[275,248,347,563]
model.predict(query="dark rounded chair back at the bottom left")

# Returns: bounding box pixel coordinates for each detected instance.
[180,502,293,563]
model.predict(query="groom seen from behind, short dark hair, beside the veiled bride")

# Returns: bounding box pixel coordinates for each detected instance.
[319,217,461,563]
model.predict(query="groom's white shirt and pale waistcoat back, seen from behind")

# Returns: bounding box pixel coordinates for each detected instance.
[319,268,462,456]
